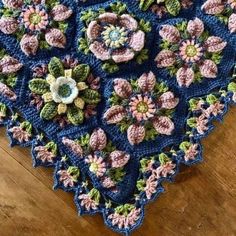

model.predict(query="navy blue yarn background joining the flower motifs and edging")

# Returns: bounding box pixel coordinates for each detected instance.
[0,0,236,235]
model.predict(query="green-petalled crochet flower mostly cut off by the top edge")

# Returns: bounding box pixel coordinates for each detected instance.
[139,0,193,18]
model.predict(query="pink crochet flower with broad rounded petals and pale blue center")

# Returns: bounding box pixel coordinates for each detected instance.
[86,12,145,63]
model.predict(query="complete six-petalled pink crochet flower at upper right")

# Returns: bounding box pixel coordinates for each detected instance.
[155,18,227,87]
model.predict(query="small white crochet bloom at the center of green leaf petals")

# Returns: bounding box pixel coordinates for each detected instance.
[50,77,79,104]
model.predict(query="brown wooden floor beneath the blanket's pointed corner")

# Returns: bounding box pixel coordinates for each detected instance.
[0,108,236,236]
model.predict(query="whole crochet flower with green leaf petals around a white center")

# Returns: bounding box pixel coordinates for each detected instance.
[29,57,100,125]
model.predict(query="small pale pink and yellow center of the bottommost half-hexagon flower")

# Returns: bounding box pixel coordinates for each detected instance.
[85,155,106,177]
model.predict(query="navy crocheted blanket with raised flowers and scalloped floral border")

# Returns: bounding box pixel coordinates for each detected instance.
[0,0,236,235]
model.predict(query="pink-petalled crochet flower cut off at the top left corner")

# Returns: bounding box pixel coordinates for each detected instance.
[0,0,72,56]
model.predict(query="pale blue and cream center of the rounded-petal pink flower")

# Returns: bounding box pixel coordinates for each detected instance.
[102,25,128,49]
